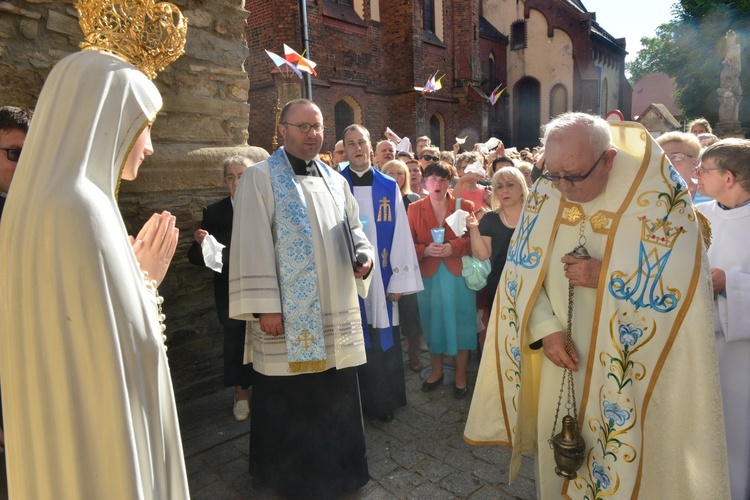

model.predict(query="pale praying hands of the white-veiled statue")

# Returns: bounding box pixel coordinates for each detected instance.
[130,211,180,286]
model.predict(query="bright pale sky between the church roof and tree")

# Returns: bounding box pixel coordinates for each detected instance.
[581,0,676,61]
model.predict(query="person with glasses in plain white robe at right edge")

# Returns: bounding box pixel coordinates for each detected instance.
[693,139,750,498]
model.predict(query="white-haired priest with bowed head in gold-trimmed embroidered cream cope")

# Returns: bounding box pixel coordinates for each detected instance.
[464,113,728,499]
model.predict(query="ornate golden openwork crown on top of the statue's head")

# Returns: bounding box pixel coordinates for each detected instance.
[76,0,187,80]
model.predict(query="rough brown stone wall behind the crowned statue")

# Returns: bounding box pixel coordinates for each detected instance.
[0,0,267,399]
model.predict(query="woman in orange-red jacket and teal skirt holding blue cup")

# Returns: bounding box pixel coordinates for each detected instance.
[408,160,476,399]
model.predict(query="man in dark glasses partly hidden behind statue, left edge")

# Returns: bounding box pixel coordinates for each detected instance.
[0,106,31,499]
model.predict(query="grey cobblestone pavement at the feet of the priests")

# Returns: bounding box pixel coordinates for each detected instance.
[178,353,536,500]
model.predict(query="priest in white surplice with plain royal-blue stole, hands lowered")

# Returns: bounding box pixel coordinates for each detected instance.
[341,125,424,422]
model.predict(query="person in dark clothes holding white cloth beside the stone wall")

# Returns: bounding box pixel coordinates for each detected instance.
[188,156,253,421]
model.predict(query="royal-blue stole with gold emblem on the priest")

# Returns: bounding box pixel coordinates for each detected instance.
[341,167,401,352]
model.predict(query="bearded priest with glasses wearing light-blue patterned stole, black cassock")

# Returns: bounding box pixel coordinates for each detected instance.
[229,99,374,498]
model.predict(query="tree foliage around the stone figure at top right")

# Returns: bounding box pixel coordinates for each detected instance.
[627,0,750,127]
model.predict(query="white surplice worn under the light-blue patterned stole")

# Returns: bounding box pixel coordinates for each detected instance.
[229,156,374,376]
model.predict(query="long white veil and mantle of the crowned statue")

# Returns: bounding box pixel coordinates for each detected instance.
[0,34,189,499]
